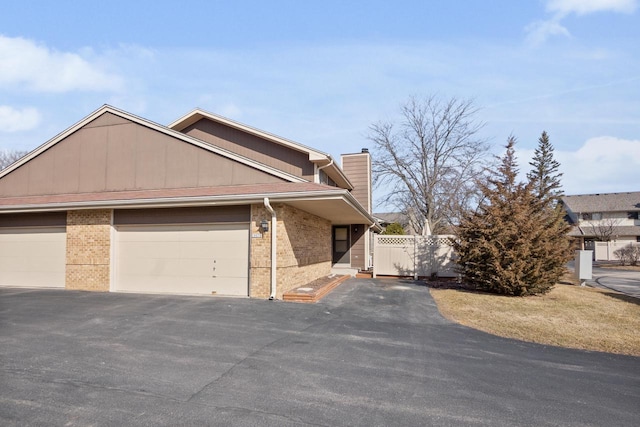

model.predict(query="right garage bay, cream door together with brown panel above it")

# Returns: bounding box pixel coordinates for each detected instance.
[113,206,249,296]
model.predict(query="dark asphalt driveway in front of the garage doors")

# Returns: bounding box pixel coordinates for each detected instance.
[0,279,640,426]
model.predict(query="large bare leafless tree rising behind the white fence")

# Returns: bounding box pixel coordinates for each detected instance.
[368,95,489,234]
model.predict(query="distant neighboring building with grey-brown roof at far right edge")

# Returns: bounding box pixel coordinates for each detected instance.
[561,191,640,250]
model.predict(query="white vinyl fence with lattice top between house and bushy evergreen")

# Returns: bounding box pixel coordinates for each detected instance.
[373,234,457,278]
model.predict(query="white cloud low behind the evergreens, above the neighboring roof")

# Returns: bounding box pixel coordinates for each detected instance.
[517,136,640,194]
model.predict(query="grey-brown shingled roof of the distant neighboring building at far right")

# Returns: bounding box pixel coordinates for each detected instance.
[562,191,640,213]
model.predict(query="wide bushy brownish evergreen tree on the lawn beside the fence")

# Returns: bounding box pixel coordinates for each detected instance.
[455,137,571,296]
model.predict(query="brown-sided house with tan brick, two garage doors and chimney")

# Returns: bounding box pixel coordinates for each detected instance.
[0,105,379,299]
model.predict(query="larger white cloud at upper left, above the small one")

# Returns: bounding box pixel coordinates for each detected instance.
[0,35,123,93]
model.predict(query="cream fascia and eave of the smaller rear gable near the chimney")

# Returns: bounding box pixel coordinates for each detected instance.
[168,108,353,190]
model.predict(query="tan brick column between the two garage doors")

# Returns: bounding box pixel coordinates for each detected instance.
[65,209,111,292]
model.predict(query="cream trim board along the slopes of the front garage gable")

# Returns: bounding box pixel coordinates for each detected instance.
[0,104,307,182]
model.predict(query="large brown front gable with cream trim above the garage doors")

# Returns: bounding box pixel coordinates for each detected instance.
[0,105,306,197]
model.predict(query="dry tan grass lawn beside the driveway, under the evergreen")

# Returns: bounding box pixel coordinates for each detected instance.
[431,284,640,356]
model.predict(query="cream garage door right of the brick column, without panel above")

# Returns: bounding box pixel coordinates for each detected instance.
[114,223,249,296]
